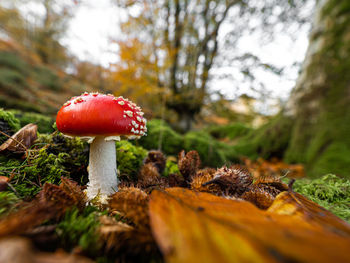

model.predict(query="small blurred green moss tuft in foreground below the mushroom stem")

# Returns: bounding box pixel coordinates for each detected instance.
[56,206,101,255]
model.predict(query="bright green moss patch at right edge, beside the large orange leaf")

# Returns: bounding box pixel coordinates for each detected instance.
[293,174,350,222]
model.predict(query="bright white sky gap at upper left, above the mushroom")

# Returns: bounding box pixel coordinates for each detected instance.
[62,0,124,67]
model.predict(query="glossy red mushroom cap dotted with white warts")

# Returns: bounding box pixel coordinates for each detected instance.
[56,92,147,136]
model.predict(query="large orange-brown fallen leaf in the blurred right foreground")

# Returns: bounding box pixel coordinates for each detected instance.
[150,188,350,262]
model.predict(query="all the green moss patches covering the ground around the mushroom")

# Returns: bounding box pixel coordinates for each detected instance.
[0,110,350,262]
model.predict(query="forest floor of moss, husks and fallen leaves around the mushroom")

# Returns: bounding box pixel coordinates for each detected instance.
[0,114,350,262]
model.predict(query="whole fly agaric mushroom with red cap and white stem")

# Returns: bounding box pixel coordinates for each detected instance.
[56,92,147,202]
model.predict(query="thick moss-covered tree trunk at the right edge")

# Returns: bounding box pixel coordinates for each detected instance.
[285,0,350,177]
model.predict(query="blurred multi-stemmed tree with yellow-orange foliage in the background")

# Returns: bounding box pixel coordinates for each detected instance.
[114,0,308,131]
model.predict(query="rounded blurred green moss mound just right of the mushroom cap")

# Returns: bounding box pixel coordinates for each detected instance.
[138,120,183,155]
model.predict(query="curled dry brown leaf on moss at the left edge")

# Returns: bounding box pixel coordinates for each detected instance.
[0,123,38,152]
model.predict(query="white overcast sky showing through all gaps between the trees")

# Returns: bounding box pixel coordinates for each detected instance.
[11,0,308,112]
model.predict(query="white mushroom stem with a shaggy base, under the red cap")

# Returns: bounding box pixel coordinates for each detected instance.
[86,136,118,202]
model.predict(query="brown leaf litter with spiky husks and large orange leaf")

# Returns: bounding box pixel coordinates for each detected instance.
[0,142,350,262]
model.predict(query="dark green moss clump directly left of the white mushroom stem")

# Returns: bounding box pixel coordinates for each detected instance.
[0,134,89,199]
